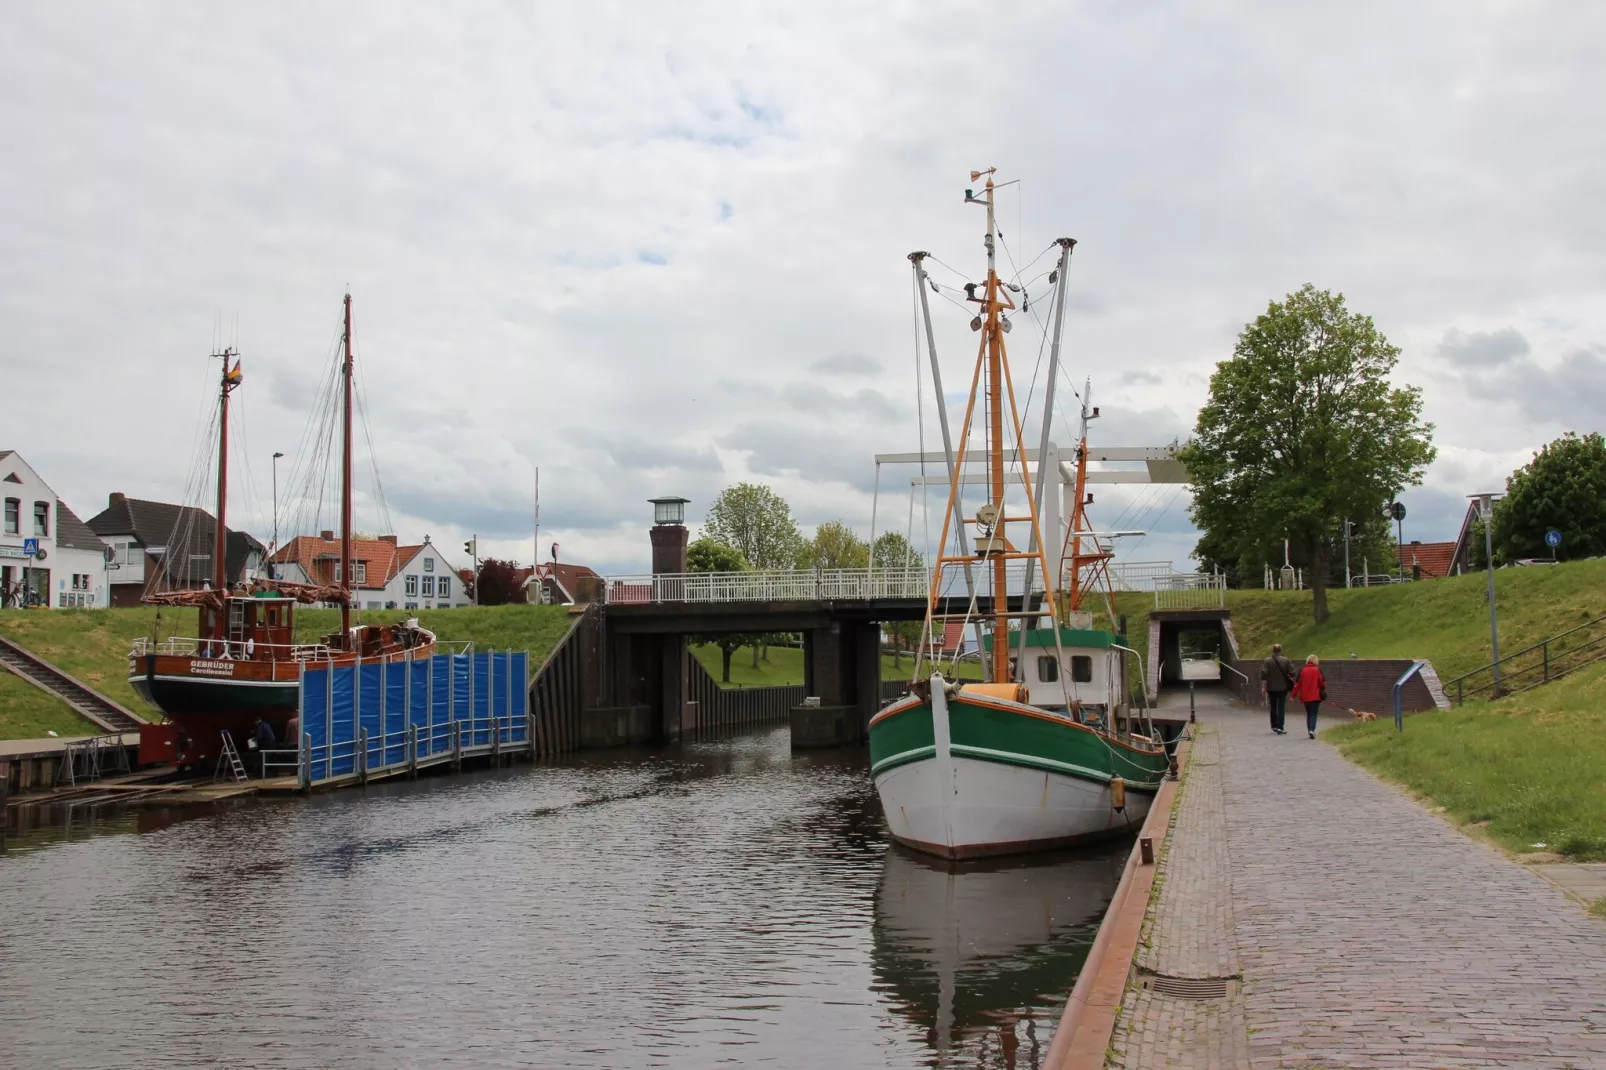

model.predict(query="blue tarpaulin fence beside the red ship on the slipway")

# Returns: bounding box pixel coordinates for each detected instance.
[300,651,530,782]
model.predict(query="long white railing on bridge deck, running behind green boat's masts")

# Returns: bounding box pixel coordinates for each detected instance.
[604,561,1042,606]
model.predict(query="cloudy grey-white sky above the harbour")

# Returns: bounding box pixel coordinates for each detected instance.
[0,0,1606,570]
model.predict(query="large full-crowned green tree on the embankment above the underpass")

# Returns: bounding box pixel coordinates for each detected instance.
[1180,284,1436,622]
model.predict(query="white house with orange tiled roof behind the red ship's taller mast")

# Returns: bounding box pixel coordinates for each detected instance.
[268,532,471,609]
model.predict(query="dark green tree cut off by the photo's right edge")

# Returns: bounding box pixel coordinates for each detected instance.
[1478,431,1606,562]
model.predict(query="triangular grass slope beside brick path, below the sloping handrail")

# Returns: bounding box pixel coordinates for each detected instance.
[1327,664,1606,861]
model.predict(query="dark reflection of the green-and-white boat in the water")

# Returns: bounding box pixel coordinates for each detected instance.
[872,843,1126,1067]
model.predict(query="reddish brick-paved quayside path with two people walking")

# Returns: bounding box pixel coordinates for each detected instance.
[1113,690,1606,1070]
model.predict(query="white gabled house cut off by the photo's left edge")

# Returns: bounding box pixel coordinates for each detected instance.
[0,450,109,609]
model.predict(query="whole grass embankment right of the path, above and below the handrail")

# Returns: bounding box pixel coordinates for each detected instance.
[1182,561,1606,861]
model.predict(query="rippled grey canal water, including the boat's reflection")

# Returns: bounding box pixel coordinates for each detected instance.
[0,719,1127,1070]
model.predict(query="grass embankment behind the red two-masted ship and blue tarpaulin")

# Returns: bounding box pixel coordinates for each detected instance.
[0,606,570,739]
